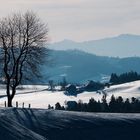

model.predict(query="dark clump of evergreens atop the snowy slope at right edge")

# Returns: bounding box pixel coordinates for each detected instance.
[110,71,140,85]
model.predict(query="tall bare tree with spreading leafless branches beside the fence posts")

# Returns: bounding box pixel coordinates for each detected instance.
[0,12,48,107]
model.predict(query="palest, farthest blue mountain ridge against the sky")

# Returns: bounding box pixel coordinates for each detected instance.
[49,34,140,57]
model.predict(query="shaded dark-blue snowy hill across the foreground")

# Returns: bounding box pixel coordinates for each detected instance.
[0,108,140,140]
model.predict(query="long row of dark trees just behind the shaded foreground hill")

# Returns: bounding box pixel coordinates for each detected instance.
[55,95,140,113]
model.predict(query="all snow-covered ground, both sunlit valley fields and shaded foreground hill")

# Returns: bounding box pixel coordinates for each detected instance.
[0,81,140,140]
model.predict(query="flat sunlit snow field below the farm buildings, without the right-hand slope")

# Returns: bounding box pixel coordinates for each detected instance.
[0,86,102,108]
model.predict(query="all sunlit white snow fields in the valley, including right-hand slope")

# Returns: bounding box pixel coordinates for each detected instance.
[0,81,140,108]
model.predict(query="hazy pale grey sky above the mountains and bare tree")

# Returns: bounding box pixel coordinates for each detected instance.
[0,0,140,42]
